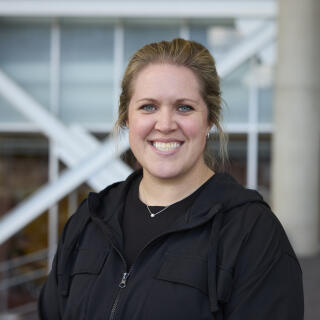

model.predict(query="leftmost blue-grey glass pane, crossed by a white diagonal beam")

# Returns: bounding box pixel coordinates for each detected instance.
[0,22,51,123]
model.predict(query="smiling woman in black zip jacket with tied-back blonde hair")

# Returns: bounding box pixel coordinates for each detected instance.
[39,39,303,320]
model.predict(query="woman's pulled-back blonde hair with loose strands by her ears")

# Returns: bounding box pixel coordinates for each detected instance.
[114,38,228,169]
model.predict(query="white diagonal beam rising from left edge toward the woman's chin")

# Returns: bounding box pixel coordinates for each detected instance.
[0,134,127,244]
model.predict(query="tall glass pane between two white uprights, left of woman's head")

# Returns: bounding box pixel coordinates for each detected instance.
[57,23,114,124]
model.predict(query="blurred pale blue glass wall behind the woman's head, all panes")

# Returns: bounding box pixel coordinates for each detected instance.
[0,20,273,130]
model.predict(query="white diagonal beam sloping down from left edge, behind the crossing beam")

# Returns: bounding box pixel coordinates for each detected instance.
[0,70,131,190]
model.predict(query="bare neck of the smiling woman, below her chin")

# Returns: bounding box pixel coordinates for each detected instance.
[139,166,214,206]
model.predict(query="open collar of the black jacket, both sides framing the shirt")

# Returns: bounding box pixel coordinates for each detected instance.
[88,170,263,247]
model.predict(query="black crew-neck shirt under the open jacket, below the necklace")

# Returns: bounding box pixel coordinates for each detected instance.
[122,176,214,266]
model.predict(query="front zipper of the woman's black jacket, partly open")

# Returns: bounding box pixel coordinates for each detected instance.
[109,205,218,320]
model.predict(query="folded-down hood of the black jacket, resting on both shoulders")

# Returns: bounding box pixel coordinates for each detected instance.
[88,170,263,222]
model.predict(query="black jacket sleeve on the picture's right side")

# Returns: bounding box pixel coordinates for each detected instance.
[222,204,304,320]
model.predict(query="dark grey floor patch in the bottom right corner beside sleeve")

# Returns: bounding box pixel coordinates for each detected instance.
[299,254,320,320]
